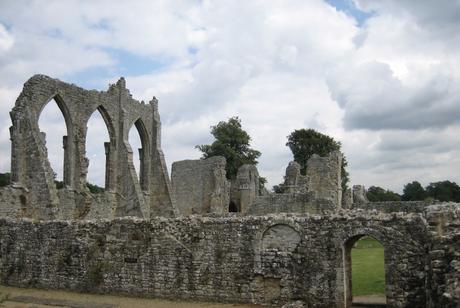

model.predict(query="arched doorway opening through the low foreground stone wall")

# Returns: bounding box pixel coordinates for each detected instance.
[345,235,386,307]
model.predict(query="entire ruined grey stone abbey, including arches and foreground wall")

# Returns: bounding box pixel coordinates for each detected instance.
[0,75,460,308]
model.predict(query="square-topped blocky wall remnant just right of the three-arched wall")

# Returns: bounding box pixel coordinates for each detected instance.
[171,156,230,215]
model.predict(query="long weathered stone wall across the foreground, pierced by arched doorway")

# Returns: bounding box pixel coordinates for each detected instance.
[0,211,438,307]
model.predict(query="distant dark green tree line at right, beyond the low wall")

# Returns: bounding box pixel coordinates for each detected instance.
[367,181,460,202]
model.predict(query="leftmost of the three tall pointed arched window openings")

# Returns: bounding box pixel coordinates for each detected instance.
[38,99,67,189]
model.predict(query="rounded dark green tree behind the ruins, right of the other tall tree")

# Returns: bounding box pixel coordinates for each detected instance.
[286,128,349,191]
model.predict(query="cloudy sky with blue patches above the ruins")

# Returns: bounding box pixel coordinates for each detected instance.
[0,0,460,191]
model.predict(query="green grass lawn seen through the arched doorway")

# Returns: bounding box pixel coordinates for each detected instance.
[351,237,385,296]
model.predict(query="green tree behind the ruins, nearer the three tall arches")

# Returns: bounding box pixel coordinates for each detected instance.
[196,117,265,182]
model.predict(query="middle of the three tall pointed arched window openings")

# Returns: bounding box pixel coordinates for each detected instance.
[86,107,110,193]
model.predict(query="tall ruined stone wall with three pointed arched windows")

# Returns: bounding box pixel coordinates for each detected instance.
[10,75,174,219]
